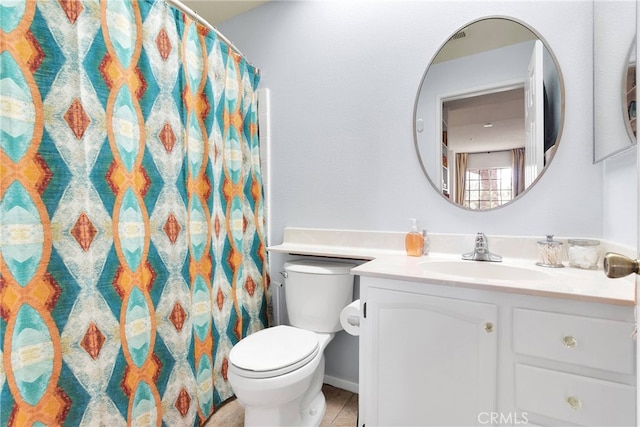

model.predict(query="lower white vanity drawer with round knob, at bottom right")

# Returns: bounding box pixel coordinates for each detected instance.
[516,364,636,426]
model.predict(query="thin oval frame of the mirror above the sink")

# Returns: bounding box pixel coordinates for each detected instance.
[411,15,566,212]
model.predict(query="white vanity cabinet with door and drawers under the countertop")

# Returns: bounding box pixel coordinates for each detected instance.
[359,276,636,426]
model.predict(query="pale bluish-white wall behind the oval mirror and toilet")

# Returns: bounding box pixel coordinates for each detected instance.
[219,0,635,392]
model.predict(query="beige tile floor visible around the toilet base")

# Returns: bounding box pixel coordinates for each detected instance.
[205,384,358,427]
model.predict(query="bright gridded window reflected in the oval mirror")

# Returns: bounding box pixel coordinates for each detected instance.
[464,168,513,209]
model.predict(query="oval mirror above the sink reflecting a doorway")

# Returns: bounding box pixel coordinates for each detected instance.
[413,18,564,210]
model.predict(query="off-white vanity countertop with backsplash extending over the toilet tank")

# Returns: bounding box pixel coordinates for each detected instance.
[267,228,635,306]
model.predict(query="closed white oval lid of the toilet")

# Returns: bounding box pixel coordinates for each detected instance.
[229,325,318,378]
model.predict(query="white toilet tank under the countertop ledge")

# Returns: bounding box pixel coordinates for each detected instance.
[284,260,355,332]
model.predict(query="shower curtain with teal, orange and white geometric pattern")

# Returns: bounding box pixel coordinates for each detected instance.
[0,0,269,426]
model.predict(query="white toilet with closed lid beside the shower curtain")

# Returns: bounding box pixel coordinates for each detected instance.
[228,260,355,426]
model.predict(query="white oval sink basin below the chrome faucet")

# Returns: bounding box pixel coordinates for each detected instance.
[420,260,551,282]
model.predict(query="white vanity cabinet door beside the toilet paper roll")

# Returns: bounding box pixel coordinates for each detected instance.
[360,288,497,426]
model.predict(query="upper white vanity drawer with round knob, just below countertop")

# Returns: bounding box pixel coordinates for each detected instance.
[513,308,635,374]
